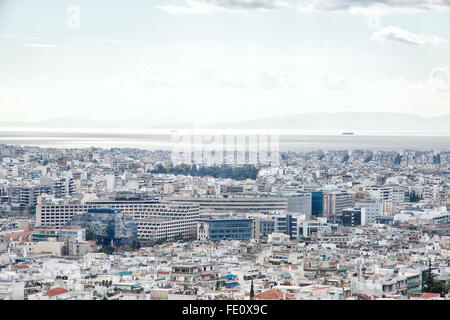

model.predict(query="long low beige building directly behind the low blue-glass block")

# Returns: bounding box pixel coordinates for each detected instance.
[166,195,288,213]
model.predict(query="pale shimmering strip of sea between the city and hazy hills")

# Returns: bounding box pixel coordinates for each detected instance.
[0,127,450,152]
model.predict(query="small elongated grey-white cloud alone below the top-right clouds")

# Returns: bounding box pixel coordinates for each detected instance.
[371,26,447,47]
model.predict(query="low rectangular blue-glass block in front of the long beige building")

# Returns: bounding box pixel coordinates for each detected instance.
[197,216,253,241]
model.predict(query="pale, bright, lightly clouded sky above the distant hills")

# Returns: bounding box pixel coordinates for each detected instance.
[0,0,450,124]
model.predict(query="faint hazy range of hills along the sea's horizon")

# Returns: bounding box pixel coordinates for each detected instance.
[0,112,450,133]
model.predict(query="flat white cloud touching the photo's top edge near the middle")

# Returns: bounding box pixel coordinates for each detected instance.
[156,0,290,14]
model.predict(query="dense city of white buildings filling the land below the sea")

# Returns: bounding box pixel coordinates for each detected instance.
[0,145,450,300]
